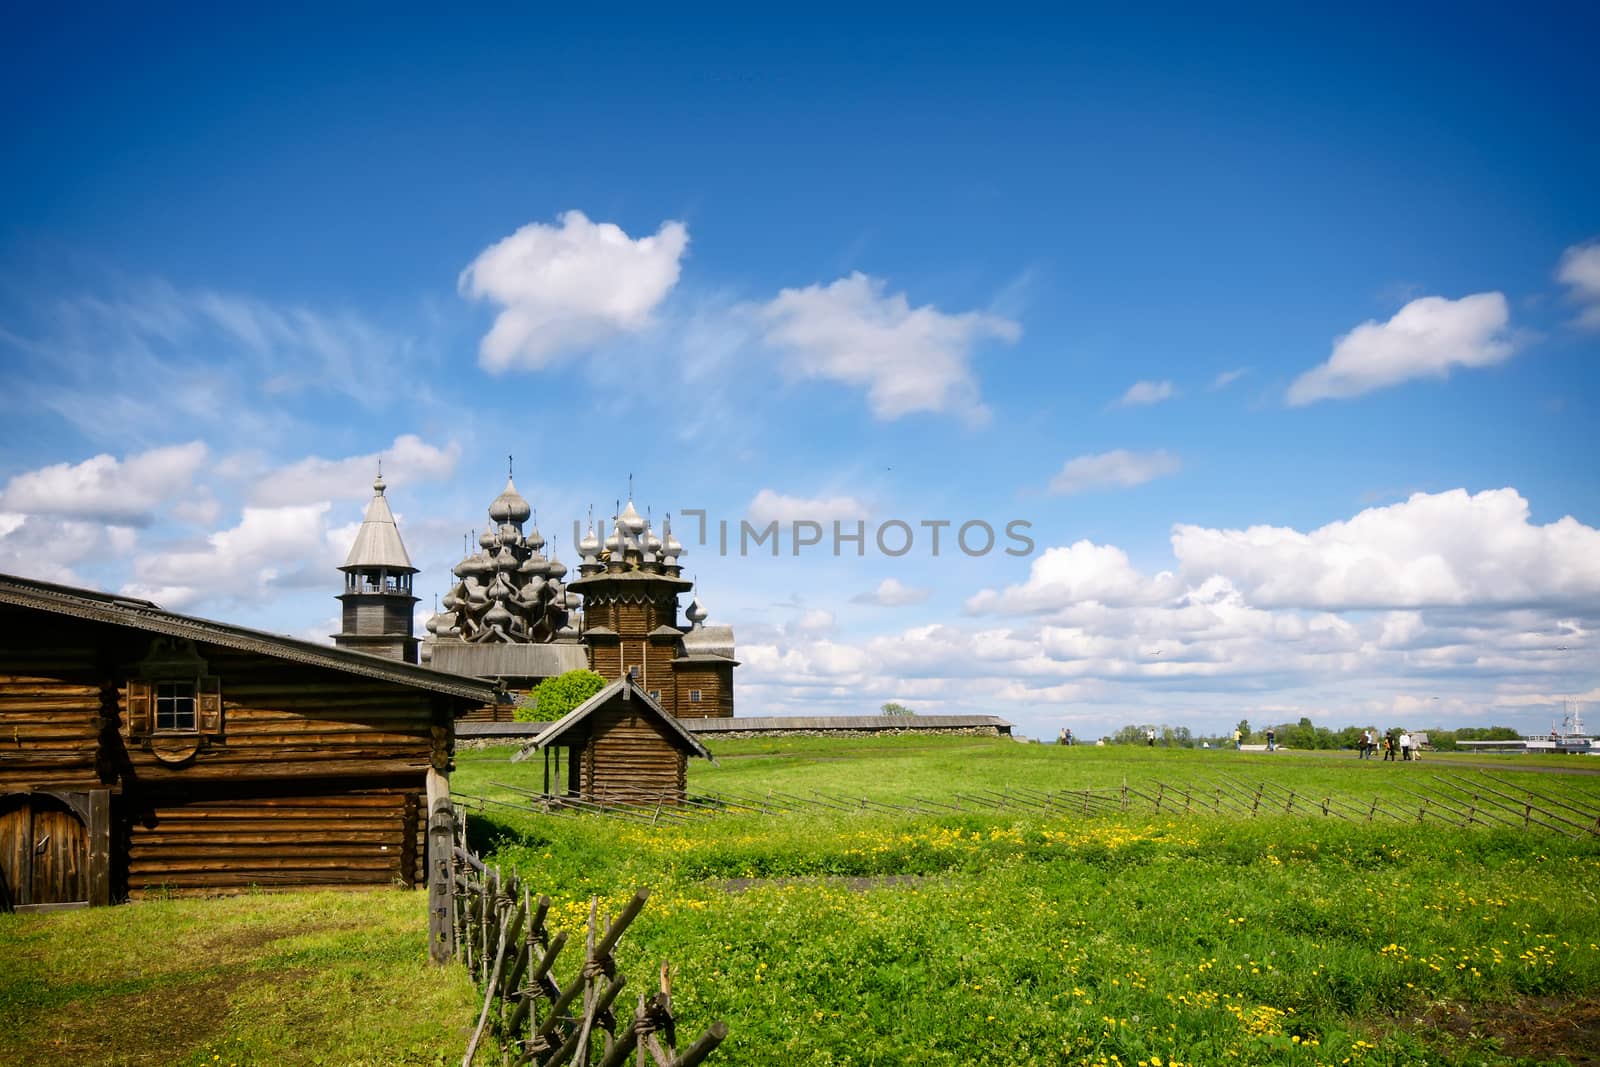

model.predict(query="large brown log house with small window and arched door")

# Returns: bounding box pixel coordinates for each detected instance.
[0,576,498,909]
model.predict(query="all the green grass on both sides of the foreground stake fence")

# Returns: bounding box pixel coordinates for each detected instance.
[0,737,1600,1067]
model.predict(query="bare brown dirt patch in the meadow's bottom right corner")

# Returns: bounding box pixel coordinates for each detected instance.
[1416,997,1600,1067]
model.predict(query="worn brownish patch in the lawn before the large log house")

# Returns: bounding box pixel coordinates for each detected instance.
[19,969,309,1067]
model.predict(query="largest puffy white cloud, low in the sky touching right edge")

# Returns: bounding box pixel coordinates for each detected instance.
[1173,488,1600,611]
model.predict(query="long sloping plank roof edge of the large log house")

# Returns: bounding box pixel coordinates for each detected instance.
[0,574,499,704]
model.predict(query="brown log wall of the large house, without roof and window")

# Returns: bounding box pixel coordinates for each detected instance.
[0,606,466,902]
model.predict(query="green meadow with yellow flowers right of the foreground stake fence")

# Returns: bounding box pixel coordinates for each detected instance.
[456,737,1600,1067]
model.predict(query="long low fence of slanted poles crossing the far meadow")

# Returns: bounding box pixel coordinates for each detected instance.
[459,771,1600,838]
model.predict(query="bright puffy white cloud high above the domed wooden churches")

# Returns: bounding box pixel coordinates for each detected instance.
[459,211,690,373]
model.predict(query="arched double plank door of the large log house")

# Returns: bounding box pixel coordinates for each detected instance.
[0,793,90,907]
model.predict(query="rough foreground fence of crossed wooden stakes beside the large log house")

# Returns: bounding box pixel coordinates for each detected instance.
[448,811,728,1067]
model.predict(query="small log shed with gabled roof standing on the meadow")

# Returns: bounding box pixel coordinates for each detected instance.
[517,677,710,803]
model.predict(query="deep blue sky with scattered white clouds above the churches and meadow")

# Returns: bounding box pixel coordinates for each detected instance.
[0,5,1600,736]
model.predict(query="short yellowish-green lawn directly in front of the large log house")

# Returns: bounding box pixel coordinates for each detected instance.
[0,891,475,1067]
